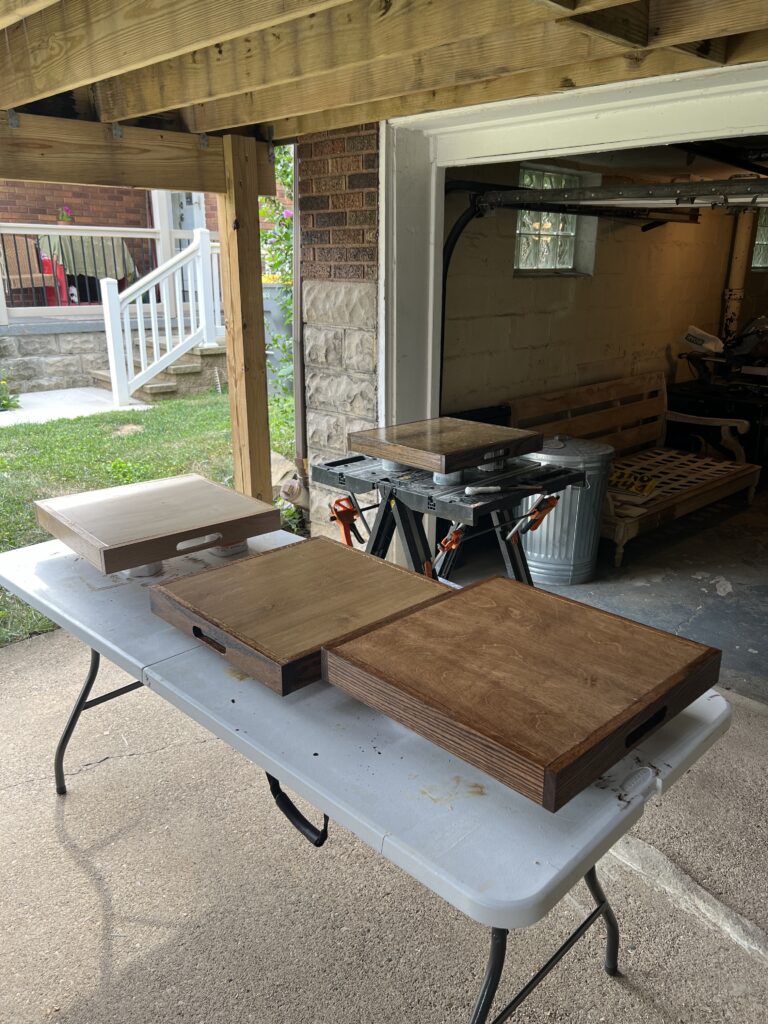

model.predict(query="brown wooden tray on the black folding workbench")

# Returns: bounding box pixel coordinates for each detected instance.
[347,416,544,473]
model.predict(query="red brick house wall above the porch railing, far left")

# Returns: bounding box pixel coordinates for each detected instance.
[0,178,152,227]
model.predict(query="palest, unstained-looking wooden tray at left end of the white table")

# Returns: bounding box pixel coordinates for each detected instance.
[35,474,280,572]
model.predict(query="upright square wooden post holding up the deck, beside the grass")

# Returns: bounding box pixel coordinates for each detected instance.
[219,135,272,502]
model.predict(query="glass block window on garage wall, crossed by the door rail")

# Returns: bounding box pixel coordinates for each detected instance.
[515,167,580,270]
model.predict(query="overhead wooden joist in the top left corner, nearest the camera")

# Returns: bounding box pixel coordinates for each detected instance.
[0,0,345,109]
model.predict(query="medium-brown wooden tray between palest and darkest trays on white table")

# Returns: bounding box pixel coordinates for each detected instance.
[150,538,452,694]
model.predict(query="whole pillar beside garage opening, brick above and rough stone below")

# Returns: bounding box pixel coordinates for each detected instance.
[296,124,379,540]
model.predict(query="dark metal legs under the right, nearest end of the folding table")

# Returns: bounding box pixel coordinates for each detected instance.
[470,867,618,1024]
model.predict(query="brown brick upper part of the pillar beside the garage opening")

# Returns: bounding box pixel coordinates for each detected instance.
[296,124,379,281]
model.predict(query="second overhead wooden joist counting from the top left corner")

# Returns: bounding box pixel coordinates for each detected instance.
[94,0,589,121]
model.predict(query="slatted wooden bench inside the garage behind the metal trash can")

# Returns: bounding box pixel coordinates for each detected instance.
[510,373,760,566]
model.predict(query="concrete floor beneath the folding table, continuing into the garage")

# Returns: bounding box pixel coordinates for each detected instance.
[0,491,768,1024]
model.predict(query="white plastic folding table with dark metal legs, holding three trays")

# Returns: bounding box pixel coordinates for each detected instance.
[0,531,730,1024]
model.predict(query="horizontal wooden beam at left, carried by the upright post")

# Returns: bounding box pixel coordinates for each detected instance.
[0,112,275,195]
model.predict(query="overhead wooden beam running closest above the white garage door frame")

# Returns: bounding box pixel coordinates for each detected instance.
[261,50,700,140]
